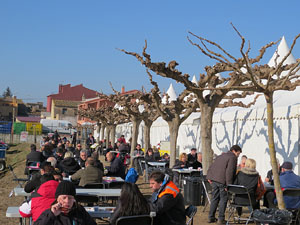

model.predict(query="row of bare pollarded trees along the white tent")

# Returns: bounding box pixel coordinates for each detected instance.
[79,26,300,209]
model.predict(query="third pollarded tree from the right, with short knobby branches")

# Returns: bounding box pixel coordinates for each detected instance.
[142,71,198,167]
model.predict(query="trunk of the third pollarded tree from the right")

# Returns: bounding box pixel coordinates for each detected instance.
[168,118,180,168]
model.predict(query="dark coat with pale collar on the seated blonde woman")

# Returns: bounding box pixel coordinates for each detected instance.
[234,167,259,206]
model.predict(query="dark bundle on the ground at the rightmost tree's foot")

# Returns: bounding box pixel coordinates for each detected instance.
[253,209,293,225]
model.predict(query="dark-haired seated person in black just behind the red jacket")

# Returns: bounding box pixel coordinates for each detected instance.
[24,162,54,193]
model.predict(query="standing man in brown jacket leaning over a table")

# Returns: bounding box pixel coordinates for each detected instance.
[207,145,242,224]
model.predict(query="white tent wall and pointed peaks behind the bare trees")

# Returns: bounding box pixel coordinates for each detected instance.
[112,37,300,179]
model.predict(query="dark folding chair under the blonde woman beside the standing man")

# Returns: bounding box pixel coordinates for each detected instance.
[226,185,253,225]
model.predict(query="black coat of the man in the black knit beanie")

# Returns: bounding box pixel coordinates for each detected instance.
[34,205,96,225]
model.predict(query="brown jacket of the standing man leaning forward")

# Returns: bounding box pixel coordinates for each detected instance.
[207,151,237,185]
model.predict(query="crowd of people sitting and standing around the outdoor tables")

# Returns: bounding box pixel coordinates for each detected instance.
[19,132,300,225]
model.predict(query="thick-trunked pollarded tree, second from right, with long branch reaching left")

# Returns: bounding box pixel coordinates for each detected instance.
[121,37,260,174]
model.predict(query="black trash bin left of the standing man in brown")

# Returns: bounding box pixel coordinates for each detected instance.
[183,177,203,206]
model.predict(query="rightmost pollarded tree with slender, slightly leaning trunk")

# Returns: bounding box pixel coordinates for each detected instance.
[219,28,300,209]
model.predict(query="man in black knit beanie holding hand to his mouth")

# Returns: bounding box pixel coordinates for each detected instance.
[34,181,96,225]
